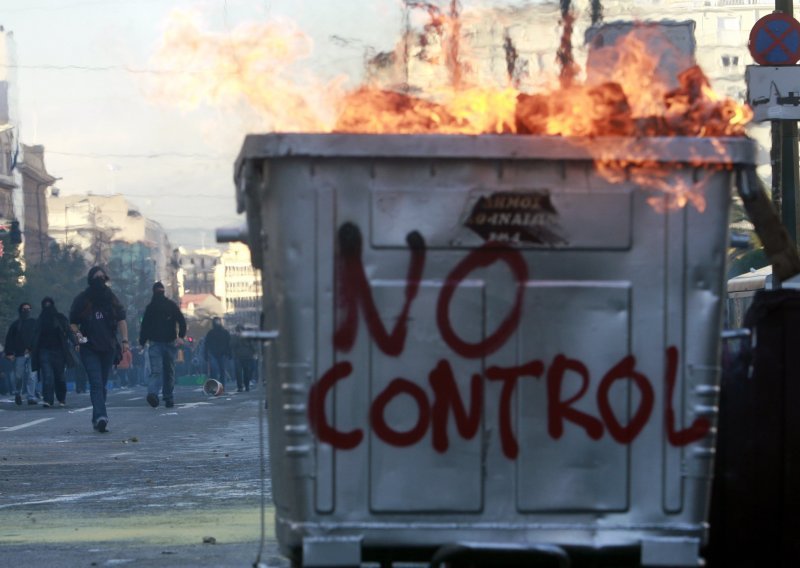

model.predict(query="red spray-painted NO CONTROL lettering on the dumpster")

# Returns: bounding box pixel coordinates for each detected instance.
[308,223,711,459]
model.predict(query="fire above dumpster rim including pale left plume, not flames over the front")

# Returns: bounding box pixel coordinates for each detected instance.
[150,13,752,137]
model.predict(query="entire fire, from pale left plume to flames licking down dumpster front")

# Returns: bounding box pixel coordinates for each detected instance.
[155,10,752,211]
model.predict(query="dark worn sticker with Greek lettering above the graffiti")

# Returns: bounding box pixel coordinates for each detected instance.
[464,191,568,246]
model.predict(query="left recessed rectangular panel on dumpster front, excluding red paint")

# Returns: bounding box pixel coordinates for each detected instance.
[369,281,485,513]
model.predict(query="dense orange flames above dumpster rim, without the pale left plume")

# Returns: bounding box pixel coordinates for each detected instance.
[334,27,752,143]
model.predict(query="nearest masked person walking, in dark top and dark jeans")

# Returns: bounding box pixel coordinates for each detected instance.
[69,266,129,432]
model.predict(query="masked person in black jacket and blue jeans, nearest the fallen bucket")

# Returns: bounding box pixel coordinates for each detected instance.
[139,282,186,408]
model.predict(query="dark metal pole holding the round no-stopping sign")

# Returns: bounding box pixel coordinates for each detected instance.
[773,0,800,243]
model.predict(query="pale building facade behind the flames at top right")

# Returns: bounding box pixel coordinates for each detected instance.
[382,0,775,98]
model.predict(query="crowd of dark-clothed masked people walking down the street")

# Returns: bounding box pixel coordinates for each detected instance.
[0,266,260,433]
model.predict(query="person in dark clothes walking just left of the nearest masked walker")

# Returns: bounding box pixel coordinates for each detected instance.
[31,297,78,408]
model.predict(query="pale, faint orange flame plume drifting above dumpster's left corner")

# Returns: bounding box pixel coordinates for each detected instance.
[150,10,342,132]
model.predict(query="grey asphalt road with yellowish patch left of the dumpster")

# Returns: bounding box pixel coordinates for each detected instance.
[0,386,289,568]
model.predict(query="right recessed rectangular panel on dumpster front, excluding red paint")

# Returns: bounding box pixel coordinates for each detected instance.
[517,281,631,512]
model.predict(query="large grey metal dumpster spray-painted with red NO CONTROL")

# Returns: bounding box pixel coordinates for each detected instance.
[236,134,754,566]
